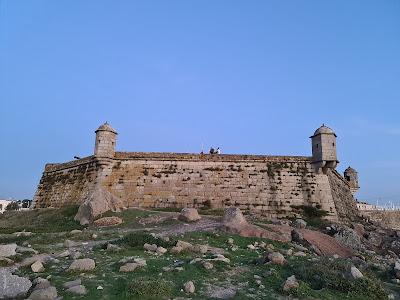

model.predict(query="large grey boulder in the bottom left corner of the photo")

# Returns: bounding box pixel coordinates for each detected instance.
[0,268,32,299]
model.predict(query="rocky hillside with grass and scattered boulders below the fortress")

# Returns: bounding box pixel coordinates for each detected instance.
[0,207,400,300]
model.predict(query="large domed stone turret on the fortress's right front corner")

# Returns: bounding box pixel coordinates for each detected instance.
[310,124,339,173]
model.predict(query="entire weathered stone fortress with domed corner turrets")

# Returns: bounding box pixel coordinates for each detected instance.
[34,123,359,220]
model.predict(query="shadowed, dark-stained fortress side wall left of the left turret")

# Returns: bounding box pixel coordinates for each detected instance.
[33,156,99,208]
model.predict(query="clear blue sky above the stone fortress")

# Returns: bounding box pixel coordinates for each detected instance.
[0,0,400,201]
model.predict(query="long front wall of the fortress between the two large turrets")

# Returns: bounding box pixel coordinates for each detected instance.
[102,152,336,217]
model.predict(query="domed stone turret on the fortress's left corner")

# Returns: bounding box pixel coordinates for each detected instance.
[94,122,117,158]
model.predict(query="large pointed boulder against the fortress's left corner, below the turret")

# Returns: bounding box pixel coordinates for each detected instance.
[74,184,123,225]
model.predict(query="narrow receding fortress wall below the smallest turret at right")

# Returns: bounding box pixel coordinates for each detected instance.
[327,169,358,220]
